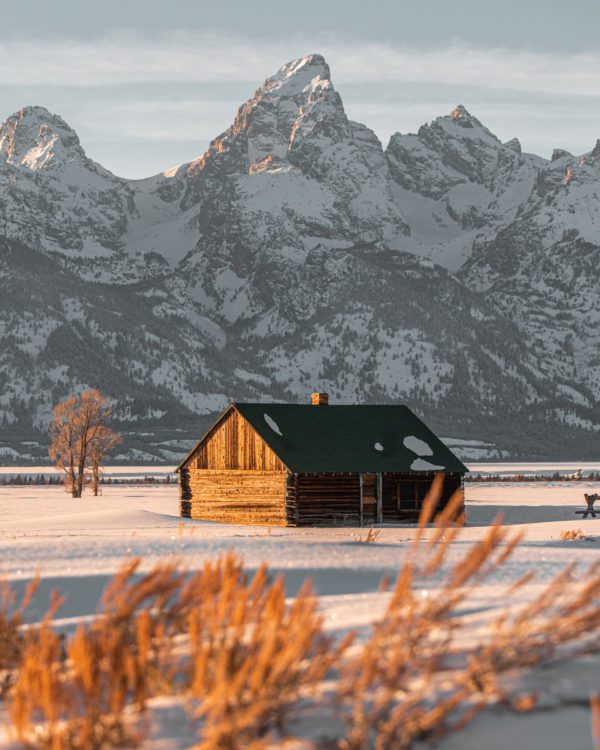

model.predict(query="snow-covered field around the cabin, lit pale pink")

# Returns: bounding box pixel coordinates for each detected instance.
[0,482,600,750]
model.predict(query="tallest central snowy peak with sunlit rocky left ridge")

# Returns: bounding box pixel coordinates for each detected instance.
[184,54,405,231]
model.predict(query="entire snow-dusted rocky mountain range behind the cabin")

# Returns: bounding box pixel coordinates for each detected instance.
[0,55,600,461]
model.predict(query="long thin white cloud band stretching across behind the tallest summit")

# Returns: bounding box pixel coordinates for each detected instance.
[0,32,600,96]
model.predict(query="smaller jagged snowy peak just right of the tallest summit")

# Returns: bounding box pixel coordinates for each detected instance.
[386,105,545,270]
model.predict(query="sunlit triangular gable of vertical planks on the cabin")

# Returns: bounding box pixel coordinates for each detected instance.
[187,409,285,471]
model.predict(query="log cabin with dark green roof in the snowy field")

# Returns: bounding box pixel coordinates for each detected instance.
[177,393,467,526]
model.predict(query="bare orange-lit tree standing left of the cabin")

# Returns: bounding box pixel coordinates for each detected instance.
[49,388,118,497]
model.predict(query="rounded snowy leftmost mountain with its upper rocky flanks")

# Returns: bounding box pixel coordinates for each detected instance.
[0,107,132,261]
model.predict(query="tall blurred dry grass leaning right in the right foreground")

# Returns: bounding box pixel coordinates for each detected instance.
[338,478,600,750]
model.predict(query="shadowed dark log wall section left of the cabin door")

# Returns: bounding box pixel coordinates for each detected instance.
[286,474,360,526]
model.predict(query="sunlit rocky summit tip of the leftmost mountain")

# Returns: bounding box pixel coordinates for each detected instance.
[0,106,86,171]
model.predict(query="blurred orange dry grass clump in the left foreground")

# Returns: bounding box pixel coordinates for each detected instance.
[4,554,346,750]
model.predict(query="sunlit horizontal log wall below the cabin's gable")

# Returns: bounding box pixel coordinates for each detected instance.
[182,469,286,526]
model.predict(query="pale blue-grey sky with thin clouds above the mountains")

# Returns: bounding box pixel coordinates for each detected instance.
[0,0,600,177]
